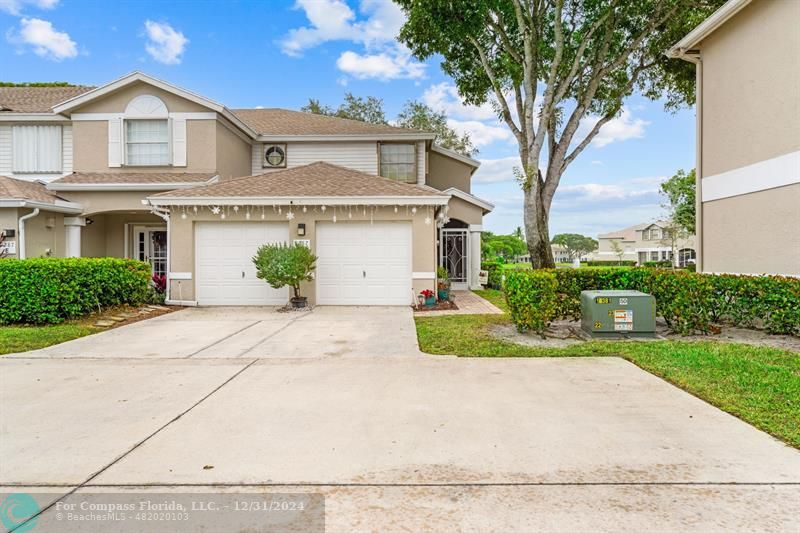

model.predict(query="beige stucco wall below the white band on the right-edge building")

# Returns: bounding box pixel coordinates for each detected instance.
[703,184,800,276]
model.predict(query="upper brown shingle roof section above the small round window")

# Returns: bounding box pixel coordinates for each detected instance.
[231,108,425,135]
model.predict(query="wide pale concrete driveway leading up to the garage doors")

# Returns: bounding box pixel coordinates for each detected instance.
[0,308,800,531]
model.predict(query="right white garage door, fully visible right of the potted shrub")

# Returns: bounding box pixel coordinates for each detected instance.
[316,222,413,305]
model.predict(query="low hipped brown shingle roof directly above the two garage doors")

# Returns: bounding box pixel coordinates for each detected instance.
[154,161,447,198]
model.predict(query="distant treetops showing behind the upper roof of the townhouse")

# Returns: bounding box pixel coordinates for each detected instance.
[300,92,478,157]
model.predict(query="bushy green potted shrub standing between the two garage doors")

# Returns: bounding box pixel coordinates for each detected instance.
[253,243,317,309]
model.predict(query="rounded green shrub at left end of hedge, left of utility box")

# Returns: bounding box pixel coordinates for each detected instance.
[505,270,558,334]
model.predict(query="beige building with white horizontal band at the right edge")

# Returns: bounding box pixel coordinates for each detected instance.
[668,0,800,276]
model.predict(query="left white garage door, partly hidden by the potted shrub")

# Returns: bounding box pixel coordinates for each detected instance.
[194,222,289,305]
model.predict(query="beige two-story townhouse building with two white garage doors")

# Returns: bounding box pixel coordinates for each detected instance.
[0,72,493,305]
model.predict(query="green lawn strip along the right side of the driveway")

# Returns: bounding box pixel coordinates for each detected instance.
[416,290,800,448]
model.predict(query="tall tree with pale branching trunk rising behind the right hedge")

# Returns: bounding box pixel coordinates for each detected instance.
[396,0,724,268]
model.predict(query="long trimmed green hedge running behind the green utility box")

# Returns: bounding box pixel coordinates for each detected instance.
[505,268,800,335]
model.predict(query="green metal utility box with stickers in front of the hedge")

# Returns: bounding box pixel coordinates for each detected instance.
[581,291,656,338]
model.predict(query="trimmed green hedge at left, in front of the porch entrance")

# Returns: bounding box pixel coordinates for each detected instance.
[0,257,150,324]
